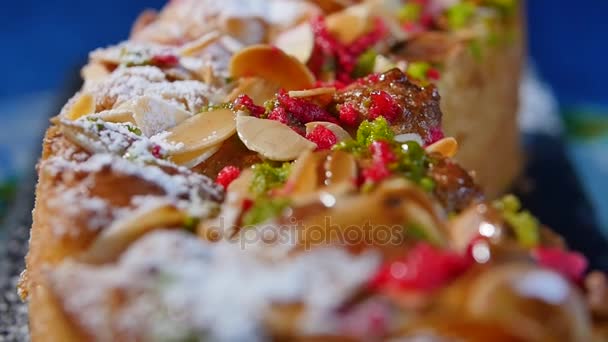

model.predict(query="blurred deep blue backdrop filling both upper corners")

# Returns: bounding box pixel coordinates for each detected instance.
[0,0,608,106]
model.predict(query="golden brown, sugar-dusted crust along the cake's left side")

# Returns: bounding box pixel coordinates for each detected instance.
[26,125,223,341]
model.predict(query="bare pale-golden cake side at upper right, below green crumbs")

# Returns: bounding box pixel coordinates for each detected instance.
[439,32,523,197]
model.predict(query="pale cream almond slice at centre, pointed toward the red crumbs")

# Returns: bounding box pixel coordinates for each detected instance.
[236,115,317,161]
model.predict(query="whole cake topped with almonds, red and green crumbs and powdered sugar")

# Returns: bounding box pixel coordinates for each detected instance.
[20,0,608,341]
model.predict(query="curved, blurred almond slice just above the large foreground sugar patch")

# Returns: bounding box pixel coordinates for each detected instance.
[80,202,187,264]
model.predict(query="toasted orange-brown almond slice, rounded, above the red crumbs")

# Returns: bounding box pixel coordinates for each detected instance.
[229,45,315,90]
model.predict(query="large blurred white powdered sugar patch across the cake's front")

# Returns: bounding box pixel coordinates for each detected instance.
[52,231,379,341]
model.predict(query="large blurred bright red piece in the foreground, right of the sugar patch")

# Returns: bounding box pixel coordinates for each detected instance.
[369,242,472,291]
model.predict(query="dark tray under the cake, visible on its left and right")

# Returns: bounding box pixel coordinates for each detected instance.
[0,82,608,341]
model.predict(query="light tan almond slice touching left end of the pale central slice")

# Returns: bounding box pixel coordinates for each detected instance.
[167,109,236,154]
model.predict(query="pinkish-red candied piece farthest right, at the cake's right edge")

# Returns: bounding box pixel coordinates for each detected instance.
[532,247,589,283]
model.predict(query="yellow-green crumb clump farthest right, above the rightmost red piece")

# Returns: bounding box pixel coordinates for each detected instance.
[493,195,540,248]
